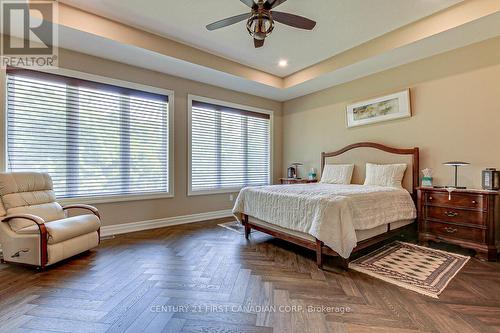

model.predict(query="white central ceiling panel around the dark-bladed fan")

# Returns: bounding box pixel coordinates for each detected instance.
[60,0,462,76]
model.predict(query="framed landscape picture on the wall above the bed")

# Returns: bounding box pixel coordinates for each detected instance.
[347,89,411,127]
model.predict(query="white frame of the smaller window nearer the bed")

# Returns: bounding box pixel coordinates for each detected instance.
[187,94,274,196]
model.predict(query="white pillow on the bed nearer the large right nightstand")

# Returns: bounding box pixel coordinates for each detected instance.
[365,163,407,188]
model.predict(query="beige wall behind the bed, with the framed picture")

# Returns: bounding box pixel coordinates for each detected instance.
[283,38,500,188]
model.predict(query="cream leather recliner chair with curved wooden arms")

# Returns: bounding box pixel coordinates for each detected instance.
[0,172,101,268]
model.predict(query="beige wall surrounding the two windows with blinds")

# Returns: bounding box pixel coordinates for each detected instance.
[0,50,282,225]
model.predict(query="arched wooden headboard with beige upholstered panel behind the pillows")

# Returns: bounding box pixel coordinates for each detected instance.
[321,142,420,198]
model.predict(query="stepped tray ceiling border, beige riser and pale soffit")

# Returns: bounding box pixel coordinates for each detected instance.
[21,0,500,101]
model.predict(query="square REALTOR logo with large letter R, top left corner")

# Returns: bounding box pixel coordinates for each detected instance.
[0,0,58,68]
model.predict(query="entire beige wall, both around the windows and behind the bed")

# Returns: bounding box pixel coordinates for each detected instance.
[0,34,500,225]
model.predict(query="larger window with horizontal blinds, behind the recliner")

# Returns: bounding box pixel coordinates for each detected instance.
[7,68,174,199]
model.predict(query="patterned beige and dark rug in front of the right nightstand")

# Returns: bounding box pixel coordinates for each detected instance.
[349,242,470,298]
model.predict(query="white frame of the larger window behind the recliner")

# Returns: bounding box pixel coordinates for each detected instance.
[0,68,175,205]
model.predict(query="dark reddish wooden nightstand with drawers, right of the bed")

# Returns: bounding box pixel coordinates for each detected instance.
[418,188,500,260]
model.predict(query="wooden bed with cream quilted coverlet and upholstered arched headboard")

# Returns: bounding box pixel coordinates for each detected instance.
[233,142,419,268]
